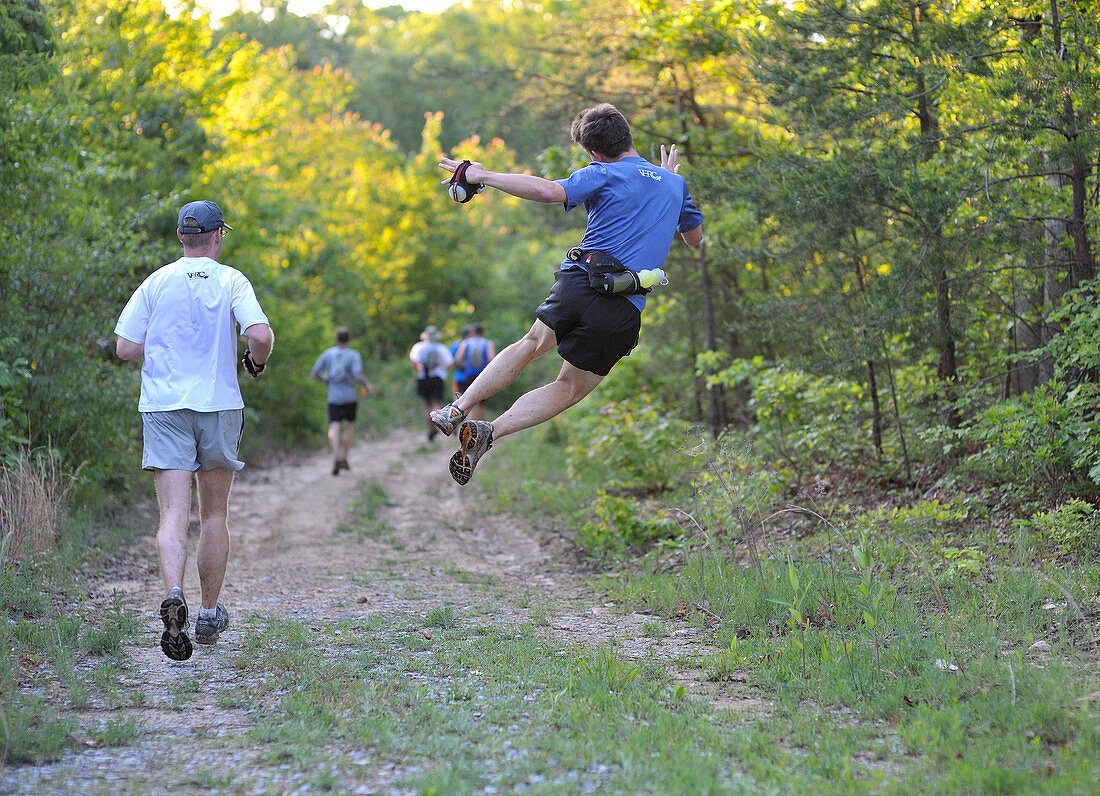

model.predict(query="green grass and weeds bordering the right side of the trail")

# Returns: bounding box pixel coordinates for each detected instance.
[464,426,1100,794]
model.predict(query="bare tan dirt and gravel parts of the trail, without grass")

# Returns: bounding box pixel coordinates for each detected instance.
[0,431,743,794]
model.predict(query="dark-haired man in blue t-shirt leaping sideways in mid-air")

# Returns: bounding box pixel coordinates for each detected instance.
[431,103,703,485]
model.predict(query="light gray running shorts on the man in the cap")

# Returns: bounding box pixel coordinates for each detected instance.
[141,409,244,473]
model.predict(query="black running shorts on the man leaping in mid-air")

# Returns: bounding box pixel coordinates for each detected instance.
[535,268,641,376]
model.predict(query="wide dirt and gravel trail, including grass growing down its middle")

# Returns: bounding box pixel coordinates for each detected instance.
[0,431,749,794]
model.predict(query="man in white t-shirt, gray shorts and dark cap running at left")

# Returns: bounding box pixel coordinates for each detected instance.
[114,201,275,661]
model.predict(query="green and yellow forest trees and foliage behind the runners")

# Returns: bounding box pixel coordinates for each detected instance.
[0,0,1100,510]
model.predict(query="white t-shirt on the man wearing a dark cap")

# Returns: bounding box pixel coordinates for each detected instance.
[114,257,267,412]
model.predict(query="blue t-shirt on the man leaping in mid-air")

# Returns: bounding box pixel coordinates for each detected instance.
[558,157,703,310]
